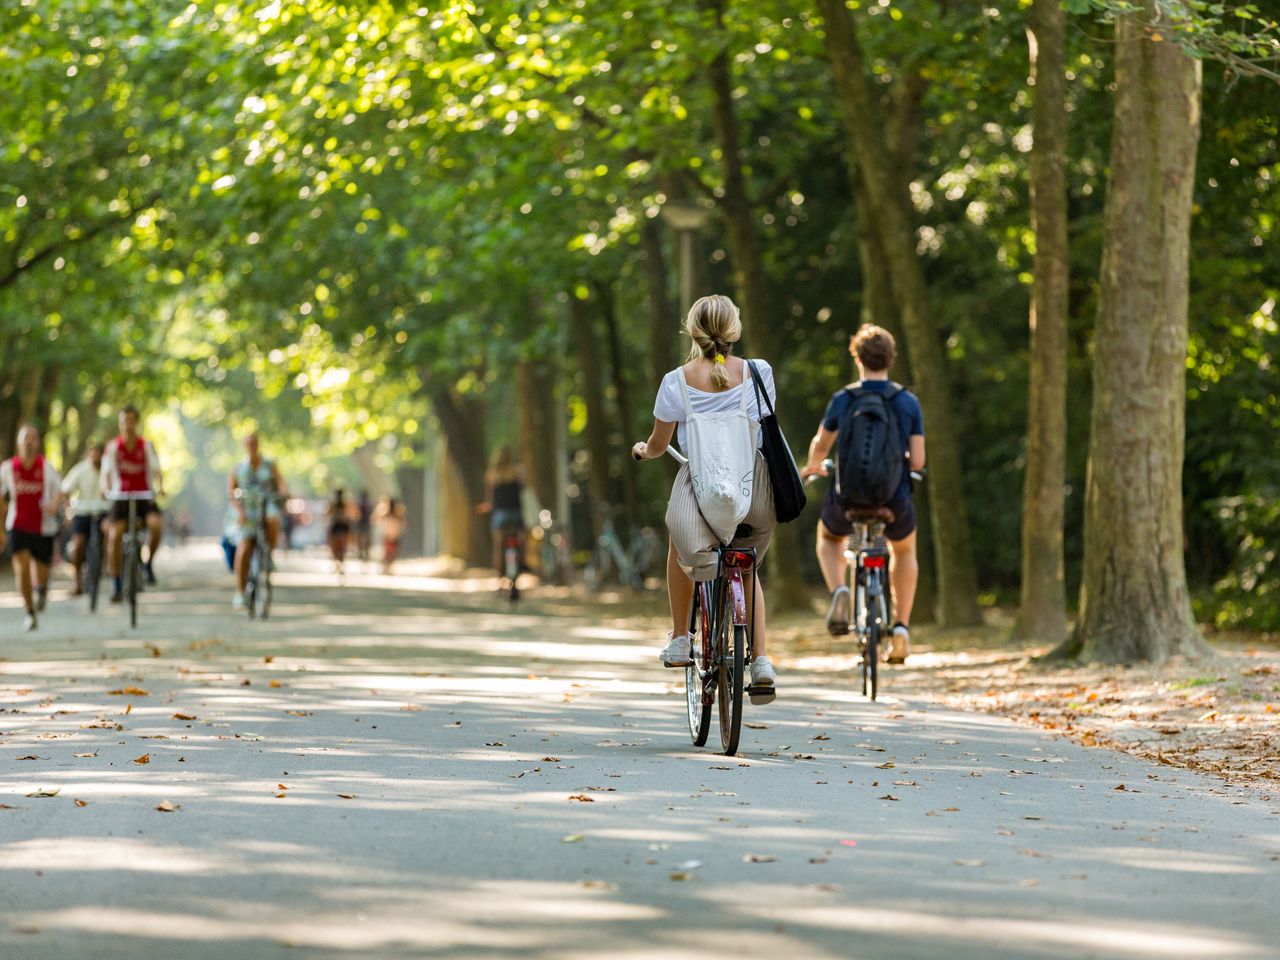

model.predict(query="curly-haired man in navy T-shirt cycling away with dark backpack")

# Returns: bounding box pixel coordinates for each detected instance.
[800,324,924,663]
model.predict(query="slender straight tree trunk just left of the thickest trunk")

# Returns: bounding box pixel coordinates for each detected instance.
[1014,0,1070,644]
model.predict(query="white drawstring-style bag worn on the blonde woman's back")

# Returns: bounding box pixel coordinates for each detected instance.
[680,365,755,544]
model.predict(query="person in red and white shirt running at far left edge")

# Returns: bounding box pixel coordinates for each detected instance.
[0,426,61,631]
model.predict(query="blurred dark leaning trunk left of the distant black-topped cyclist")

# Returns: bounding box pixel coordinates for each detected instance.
[422,374,493,567]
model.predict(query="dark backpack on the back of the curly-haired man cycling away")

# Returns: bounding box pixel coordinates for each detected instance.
[836,383,906,508]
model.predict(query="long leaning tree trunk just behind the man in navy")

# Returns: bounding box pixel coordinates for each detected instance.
[818,0,982,626]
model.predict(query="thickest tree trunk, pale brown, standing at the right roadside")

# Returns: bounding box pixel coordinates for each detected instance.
[1060,7,1210,662]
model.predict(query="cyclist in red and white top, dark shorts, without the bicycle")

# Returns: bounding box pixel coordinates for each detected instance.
[101,406,164,603]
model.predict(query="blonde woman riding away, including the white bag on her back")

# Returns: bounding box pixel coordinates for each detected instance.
[631,294,777,704]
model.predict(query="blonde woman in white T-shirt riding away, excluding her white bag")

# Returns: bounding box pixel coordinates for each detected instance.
[631,294,777,703]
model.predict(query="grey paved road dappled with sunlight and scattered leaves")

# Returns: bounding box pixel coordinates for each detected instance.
[0,550,1280,960]
